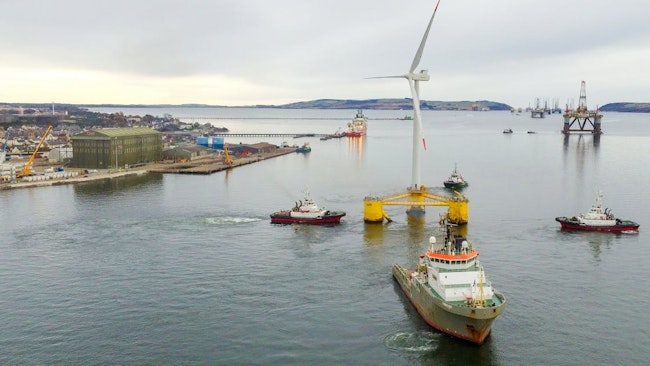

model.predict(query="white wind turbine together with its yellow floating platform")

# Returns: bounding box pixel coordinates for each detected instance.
[363,0,469,224]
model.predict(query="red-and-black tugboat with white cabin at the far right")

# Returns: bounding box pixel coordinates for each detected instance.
[555,192,639,233]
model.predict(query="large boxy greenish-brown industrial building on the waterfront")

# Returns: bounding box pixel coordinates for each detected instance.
[71,127,162,169]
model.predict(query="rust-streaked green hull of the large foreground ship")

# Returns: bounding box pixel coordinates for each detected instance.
[393,264,506,344]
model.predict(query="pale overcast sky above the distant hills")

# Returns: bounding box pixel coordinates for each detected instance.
[0,0,650,109]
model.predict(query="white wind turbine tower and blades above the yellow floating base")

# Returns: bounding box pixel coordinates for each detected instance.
[372,0,440,189]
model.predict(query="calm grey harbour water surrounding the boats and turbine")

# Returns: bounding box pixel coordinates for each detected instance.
[0,109,650,365]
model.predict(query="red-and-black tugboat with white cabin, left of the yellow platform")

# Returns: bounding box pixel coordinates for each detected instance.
[271,191,345,225]
